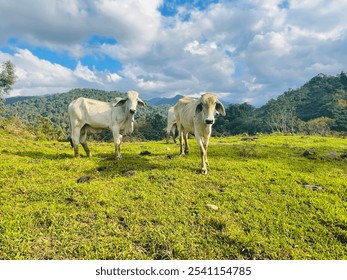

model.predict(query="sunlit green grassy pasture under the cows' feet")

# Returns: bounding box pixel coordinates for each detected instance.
[0,126,347,259]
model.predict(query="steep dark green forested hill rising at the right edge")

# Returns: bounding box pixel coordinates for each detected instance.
[259,72,347,131]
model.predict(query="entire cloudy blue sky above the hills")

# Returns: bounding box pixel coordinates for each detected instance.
[0,0,347,106]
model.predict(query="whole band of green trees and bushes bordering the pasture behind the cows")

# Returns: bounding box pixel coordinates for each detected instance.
[0,72,347,141]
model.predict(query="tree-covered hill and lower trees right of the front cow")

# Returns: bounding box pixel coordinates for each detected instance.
[215,72,347,135]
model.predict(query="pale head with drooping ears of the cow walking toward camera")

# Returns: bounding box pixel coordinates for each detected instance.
[195,93,225,124]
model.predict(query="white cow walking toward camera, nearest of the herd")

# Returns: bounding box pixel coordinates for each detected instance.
[174,93,225,174]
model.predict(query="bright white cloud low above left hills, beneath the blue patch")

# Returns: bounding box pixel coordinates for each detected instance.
[0,49,122,96]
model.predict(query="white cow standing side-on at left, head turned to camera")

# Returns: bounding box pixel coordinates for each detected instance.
[68,91,145,159]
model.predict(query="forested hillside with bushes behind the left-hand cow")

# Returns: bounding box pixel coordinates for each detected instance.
[1,89,168,140]
